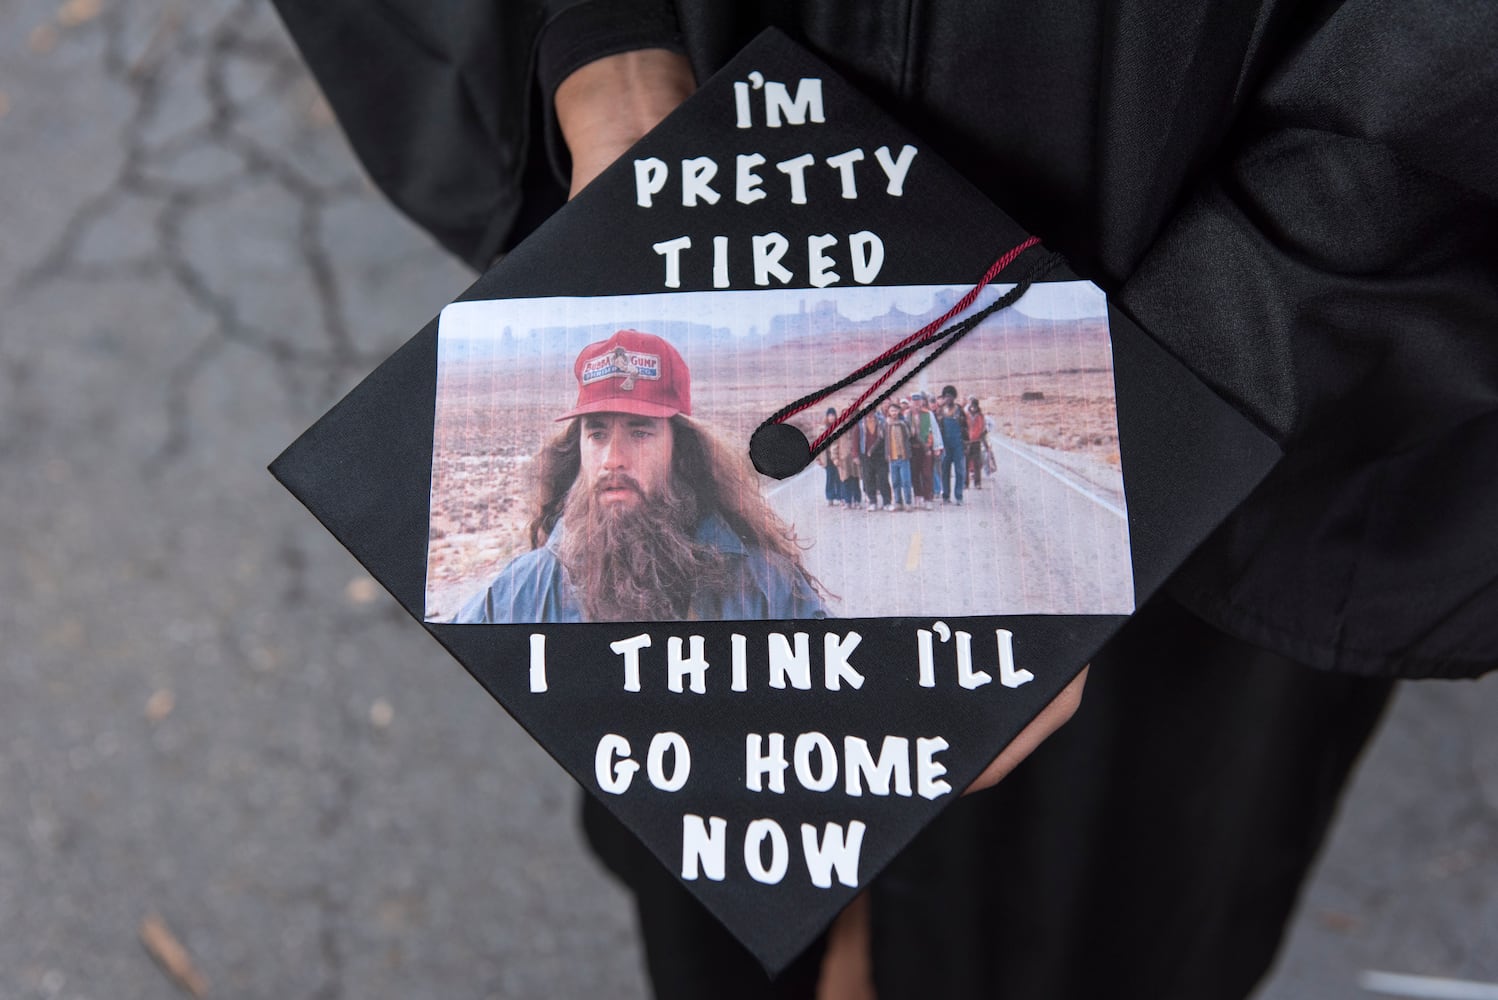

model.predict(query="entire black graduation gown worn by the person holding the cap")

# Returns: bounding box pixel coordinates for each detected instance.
[277,0,1498,999]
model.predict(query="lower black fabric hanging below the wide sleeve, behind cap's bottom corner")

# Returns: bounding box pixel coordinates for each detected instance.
[584,600,1392,1000]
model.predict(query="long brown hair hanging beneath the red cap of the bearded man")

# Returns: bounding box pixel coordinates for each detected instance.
[527,415,828,597]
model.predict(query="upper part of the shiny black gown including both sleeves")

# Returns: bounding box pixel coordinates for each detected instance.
[279,0,1498,677]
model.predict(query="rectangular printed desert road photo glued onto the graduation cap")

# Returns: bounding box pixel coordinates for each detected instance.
[425,281,1134,624]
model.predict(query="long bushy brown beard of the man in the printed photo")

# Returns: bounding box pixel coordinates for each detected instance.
[559,475,727,621]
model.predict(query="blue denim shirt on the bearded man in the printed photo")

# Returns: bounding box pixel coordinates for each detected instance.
[452,512,827,624]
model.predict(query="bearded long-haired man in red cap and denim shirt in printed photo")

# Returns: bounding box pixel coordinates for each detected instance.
[454,329,825,624]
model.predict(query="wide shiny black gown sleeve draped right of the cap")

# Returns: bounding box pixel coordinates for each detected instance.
[1118,0,1498,677]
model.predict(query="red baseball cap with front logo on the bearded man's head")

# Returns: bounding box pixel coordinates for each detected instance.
[557,329,692,421]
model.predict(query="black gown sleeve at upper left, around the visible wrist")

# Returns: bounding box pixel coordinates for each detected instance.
[274,0,682,269]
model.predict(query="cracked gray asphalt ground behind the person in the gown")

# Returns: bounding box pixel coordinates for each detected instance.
[0,0,1498,1000]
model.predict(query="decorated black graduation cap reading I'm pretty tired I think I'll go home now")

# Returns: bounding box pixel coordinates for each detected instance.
[271,30,1278,973]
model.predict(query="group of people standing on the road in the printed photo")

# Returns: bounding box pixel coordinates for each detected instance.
[818,385,993,510]
